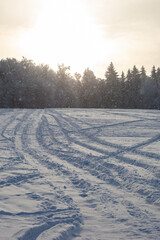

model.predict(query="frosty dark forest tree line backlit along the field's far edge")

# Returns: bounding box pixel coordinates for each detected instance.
[0,57,160,109]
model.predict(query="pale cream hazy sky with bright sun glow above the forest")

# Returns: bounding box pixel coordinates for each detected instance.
[0,0,160,77]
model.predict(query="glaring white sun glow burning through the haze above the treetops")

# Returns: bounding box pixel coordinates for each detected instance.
[19,0,116,73]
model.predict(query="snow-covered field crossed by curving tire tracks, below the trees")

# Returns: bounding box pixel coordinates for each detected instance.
[0,109,160,240]
